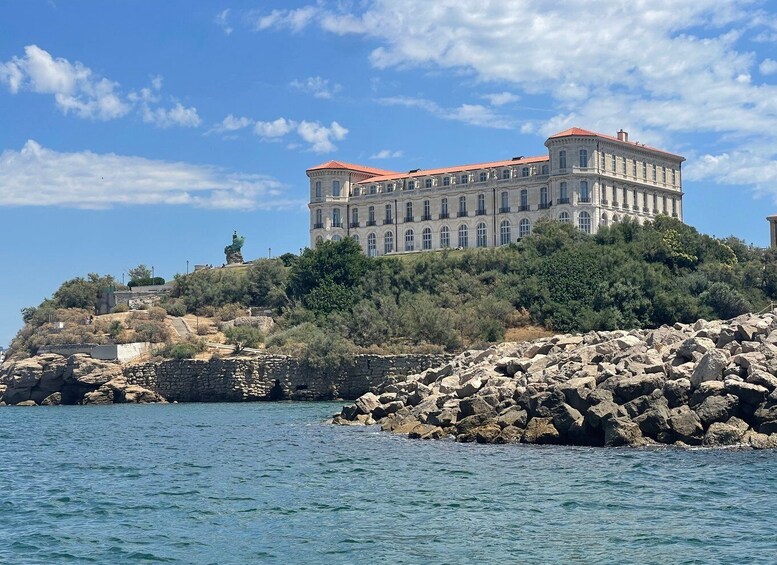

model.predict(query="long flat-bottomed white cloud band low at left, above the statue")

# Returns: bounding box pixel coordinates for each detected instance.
[0,140,302,209]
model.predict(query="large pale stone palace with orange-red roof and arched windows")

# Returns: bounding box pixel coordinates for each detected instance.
[307,128,685,256]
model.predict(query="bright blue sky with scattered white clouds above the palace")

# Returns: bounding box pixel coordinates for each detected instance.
[0,0,777,346]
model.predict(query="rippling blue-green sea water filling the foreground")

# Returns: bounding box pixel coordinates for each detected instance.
[0,403,777,564]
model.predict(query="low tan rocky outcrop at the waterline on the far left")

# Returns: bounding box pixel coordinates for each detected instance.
[0,353,165,406]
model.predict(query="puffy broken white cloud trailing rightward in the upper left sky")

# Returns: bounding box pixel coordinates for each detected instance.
[0,45,200,127]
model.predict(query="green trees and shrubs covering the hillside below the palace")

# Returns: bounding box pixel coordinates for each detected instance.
[14,217,777,362]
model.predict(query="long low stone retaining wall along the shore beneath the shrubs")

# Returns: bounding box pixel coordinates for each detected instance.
[124,354,452,402]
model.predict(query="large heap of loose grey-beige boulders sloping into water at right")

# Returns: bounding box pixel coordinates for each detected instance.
[334,311,777,449]
